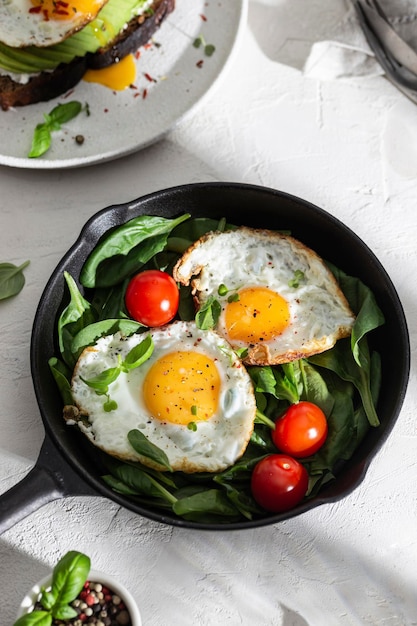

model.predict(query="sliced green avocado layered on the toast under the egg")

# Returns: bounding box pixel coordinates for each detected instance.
[0,0,152,74]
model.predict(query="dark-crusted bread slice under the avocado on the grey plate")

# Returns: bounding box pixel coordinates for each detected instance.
[0,0,175,111]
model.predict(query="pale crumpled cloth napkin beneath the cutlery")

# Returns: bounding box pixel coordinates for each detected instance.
[303,0,417,80]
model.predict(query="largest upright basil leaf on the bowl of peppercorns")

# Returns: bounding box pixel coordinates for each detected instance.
[51,550,91,607]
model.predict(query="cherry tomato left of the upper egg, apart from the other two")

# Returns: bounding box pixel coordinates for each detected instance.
[125,270,179,327]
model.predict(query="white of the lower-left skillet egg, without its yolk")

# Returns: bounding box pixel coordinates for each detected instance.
[72,321,256,473]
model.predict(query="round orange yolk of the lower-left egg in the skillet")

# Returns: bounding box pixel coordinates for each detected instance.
[143,350,220,425]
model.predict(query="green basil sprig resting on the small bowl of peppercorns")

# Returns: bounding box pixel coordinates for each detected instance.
[14,550,91,626]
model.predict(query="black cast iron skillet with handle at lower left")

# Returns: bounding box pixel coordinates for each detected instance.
[0,183,410,532]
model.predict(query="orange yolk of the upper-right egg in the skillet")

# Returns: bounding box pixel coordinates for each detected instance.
[225,287,290,343]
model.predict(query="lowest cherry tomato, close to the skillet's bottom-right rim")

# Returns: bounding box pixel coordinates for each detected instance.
[251,454,308,513]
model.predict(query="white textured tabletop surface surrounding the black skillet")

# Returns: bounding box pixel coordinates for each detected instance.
[0,0,417,626]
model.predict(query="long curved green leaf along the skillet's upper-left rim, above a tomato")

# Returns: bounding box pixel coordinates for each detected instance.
[80,213,190,287]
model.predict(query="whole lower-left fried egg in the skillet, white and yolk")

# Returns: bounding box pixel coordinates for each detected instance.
[72,321,256,473]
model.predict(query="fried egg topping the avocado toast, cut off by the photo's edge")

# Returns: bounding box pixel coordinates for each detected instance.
[0,0,107,48]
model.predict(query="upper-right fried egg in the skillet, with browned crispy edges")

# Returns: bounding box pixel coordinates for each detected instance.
[173,227,355,365]
